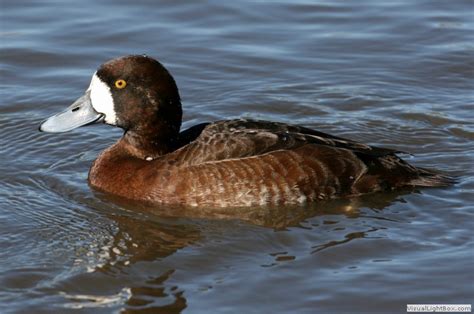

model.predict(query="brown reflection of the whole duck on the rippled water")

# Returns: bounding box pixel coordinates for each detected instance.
[84,188,412,313]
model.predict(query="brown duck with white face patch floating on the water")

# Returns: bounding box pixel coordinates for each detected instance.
[39,55,454,208]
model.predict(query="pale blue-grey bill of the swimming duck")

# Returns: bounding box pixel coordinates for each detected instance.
[39,91,104,133]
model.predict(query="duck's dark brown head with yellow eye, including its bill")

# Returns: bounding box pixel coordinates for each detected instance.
[39,55,182,138]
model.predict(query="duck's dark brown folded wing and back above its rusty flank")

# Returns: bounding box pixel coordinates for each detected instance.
[170,119,399,165]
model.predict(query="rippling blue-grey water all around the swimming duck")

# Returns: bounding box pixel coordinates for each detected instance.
[0,0,474,313]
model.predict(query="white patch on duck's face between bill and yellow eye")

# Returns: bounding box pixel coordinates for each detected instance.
[87,72,117,125]
